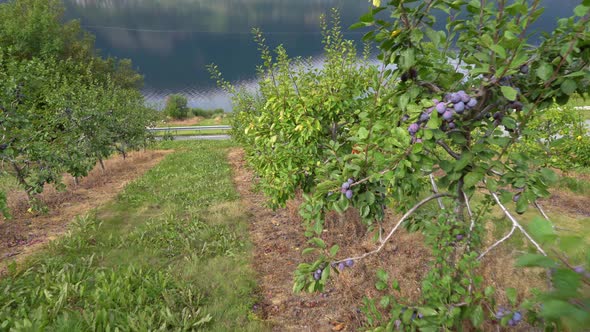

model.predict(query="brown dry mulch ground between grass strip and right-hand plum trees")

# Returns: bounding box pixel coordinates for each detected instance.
[229,149,429,331]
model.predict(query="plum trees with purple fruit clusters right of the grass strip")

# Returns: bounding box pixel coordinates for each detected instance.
[216,0,590,331]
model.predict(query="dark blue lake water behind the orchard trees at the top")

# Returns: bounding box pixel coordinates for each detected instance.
[65,0,581,110]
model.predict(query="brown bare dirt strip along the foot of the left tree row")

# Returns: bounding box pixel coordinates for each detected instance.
[0,150,171,271]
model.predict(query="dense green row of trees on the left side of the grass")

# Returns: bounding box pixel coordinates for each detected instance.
[0,0,155,215]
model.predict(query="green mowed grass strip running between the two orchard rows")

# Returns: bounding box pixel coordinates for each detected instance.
[0,142,266,331]
